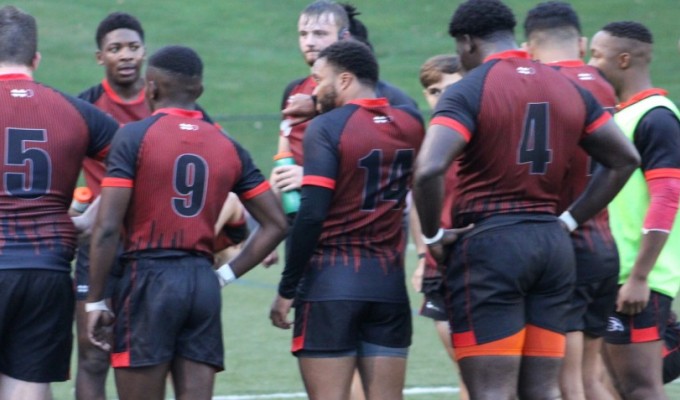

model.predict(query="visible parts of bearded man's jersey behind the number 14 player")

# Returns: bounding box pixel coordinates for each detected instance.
[279,76,418,165]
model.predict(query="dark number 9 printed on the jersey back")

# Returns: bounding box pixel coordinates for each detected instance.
[172,154,208,218]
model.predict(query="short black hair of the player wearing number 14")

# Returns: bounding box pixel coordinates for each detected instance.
[319,40,379,87]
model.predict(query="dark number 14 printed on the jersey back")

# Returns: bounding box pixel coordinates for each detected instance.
[359,149,415,211]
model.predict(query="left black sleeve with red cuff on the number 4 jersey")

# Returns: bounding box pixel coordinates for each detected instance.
[430,70,485,142]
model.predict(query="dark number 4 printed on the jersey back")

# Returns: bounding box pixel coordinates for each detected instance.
[517,103,552,175]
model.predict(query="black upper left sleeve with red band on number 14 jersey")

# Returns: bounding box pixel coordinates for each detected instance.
[302,115,341,190]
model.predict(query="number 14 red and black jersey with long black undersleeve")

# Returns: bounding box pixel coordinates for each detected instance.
[279,98,424,301]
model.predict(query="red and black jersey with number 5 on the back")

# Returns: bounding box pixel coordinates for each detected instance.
[0,74,118,272]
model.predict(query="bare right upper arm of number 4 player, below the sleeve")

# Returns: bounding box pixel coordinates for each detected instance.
[580,119,640,168]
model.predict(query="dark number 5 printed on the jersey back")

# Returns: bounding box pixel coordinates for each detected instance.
[2,128,52,199]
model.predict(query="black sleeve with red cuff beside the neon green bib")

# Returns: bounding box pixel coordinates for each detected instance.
[633,107,680,179]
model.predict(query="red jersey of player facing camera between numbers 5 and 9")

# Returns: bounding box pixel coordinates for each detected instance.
[78,79,151,196]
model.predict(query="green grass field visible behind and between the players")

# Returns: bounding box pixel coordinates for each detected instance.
[7,0,680,399]
